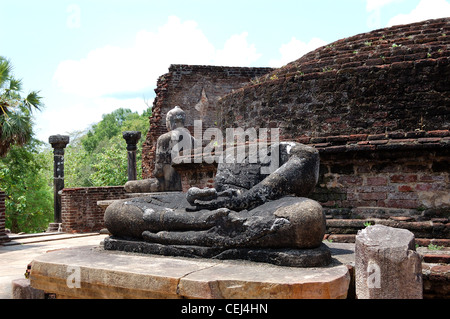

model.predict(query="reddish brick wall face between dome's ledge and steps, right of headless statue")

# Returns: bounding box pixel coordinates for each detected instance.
[310,130,450,220]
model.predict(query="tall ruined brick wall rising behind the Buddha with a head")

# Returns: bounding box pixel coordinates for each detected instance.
[142,65,273,178]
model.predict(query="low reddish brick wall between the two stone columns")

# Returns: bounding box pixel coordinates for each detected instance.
[61,186,126,233]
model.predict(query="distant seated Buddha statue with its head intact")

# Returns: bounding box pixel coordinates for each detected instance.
[124,106,194,193]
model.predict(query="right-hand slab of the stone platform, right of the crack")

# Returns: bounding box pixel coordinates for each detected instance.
[179,261,350,299]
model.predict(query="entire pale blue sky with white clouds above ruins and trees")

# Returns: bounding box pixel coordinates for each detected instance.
[0,0,450,141]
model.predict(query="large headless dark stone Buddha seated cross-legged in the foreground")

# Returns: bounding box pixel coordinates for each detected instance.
[104,138,331,267]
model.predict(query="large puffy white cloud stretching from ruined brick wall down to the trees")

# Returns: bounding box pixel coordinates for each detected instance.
[44,16,261,141]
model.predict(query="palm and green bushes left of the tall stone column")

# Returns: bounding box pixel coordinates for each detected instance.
[0,56,53,232]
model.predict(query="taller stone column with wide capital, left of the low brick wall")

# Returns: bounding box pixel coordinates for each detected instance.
[48,135,69,223]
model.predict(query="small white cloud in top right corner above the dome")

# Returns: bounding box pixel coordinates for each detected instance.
[387,0,450,27]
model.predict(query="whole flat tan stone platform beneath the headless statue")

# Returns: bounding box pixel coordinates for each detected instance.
[30,246,350,299]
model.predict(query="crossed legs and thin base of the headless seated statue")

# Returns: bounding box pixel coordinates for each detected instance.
[104,193,331,267]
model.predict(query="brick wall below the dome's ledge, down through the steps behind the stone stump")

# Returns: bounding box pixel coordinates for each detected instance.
[301,130,450,242]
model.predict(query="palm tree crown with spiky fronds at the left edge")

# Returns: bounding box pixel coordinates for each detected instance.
[0,56,43,157]
